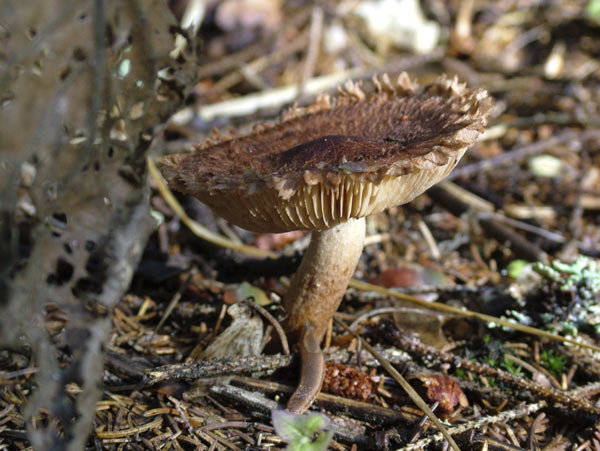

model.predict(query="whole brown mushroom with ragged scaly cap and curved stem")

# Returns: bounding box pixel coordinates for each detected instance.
[159,73,492,412]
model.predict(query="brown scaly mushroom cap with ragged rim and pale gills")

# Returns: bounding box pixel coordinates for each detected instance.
[160,73,492,232]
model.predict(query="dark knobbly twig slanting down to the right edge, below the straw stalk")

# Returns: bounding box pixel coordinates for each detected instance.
[387,326,600,415]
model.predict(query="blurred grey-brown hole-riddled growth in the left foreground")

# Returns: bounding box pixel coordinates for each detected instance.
[0,0,198,450]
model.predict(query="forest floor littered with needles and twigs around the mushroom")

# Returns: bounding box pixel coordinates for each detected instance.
[0,0,600,450]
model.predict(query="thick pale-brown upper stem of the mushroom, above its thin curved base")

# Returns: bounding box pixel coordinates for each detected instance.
[284,218,365,343]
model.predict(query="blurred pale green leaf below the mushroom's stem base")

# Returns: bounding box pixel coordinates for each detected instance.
[271,410,333,451]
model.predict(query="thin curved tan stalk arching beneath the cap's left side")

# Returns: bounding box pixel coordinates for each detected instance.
[147,157,277,258]
